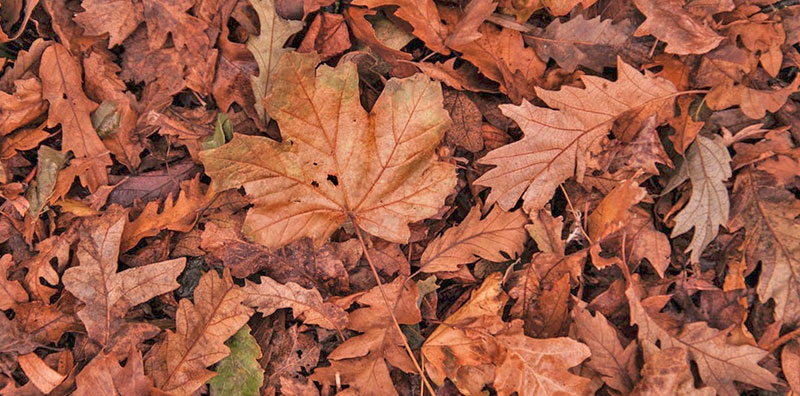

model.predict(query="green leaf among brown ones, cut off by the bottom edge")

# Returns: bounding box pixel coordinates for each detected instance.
[209,325,264,396]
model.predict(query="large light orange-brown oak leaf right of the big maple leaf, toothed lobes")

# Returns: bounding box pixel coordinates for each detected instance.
[475,60,676,212]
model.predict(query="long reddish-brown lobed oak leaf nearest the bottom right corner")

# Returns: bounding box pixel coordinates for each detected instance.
[625,286,777,396]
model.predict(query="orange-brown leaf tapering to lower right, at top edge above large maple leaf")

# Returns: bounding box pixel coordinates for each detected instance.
[352,0,450,55]
